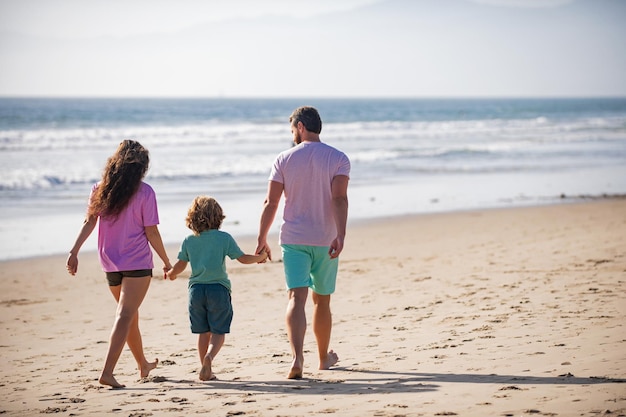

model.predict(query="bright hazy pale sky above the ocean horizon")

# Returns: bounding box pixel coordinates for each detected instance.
[0,0,626,97]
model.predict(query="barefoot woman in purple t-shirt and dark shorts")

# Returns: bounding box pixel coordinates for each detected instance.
[66,140,172,388]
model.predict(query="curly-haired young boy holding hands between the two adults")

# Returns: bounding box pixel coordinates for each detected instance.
[167,196,267,381]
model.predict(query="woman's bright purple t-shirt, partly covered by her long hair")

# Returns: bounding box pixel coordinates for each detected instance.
[90,182,159,272]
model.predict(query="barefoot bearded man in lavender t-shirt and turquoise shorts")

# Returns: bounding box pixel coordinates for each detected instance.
[256,107,350,379]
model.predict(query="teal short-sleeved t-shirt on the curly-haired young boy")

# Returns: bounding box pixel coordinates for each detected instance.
[178,229,244,291]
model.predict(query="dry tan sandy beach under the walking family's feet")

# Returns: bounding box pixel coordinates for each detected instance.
[0,199,626,417]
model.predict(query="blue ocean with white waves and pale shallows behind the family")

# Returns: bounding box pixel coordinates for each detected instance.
[0,98,626,260]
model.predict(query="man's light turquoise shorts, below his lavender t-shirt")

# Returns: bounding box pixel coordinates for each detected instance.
[280,245,339,295]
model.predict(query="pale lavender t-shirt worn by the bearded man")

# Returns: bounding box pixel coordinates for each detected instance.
[269,142,350,246]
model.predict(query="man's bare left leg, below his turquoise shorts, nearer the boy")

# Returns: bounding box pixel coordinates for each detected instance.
[285,287,309,379]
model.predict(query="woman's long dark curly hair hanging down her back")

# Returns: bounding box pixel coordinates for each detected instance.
[89,139,150,217]
